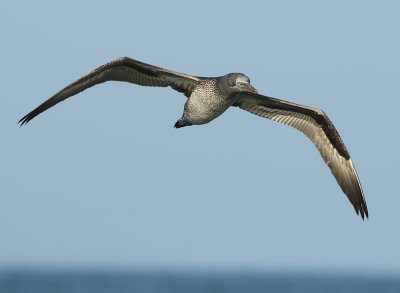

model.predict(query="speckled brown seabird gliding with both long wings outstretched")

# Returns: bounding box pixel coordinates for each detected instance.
[19,57,368,219]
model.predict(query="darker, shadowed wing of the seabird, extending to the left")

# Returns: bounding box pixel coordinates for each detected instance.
[19,57,200,125]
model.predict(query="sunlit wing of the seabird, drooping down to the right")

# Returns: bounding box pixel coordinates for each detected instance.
[234,92,368,219]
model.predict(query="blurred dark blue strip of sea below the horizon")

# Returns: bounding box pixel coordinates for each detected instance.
[0,270,400,293]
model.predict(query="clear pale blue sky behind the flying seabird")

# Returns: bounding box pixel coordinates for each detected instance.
[0,1,400,273]
